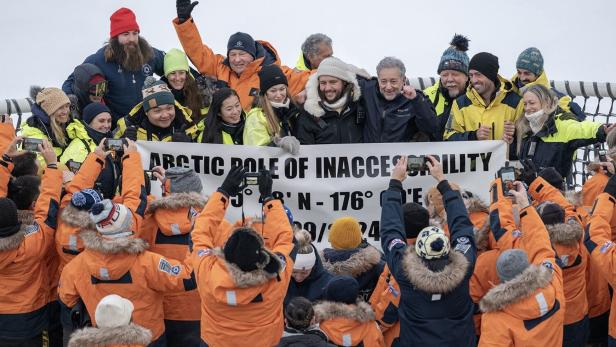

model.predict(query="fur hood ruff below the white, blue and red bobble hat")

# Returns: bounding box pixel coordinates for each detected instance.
[79,230,149,254]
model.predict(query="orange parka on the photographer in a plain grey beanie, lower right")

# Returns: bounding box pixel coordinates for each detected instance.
[479,179,565,347]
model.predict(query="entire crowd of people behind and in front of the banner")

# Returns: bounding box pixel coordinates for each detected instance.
[0,0,616,346]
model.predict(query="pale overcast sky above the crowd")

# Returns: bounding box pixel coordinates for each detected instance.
[0,0,616,99]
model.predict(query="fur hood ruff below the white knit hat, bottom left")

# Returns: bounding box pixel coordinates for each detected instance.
[68,323,152,347]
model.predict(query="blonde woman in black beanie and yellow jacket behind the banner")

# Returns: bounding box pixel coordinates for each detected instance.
[244,65,299,154]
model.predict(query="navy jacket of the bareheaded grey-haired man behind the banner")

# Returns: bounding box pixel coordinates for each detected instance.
[358,78,442,143]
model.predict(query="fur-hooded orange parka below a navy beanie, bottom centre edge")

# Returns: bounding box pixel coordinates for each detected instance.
[314,301,385,347]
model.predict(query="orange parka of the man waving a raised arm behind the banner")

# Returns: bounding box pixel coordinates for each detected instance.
[173,18,311,112]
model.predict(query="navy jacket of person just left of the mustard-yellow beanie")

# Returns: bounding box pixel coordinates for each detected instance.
[284,244,334,307]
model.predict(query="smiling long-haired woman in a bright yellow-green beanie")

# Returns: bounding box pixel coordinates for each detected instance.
[161,48,207,123]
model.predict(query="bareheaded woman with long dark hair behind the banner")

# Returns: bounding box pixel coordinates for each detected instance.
[197,88,246,145]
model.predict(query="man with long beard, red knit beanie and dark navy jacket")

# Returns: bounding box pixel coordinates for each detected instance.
[62,7,164,126]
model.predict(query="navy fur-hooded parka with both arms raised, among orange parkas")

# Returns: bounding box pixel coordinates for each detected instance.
[380,180,477,347]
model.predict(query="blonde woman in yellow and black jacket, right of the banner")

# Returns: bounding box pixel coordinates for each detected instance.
[514,85,614,177]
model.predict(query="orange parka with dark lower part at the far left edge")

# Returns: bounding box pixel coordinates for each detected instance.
[0,160,62,339]
